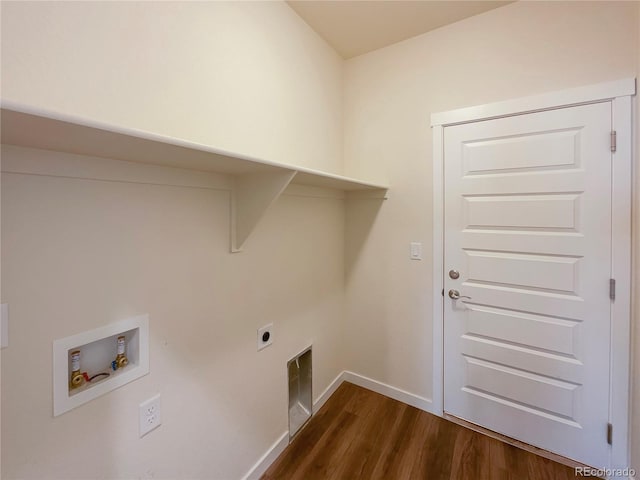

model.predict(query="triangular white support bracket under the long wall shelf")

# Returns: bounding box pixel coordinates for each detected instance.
[231,169,297,253]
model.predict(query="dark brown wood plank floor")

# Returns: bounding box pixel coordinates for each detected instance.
[262,382,576,480]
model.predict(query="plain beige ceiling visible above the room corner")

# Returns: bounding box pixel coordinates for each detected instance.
[287,0,511,58]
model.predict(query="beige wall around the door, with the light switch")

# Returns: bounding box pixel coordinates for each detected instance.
[344,2,640,465]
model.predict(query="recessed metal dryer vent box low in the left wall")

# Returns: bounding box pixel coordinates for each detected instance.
[287,347,313,439]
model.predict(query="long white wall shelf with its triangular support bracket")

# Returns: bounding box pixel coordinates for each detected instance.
[0,101,388,251]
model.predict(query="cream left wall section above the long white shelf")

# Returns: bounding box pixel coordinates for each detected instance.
[1,1,342,173]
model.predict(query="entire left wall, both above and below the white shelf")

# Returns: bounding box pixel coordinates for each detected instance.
[1,2,344,479]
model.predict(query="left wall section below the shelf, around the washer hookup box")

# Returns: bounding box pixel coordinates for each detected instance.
[2,147,344,479]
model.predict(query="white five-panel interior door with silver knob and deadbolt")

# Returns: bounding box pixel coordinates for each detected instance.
[444,102,612,467]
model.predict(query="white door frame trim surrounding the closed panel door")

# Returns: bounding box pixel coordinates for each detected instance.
[431,78,636,468]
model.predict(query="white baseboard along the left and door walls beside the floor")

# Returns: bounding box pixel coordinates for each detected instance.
[242,370,433,480]
